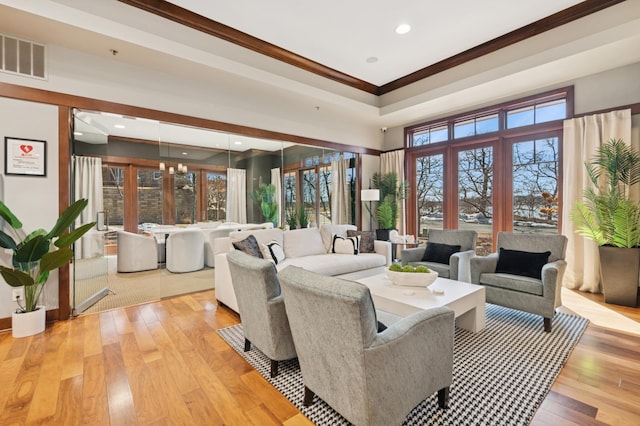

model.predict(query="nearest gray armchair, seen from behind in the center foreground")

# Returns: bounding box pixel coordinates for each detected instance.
[278,266,454,426]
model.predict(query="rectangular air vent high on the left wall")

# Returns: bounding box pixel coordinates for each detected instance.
[0,34,47,79]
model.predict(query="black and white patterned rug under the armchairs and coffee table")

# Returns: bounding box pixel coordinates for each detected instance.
[218,304,588,426]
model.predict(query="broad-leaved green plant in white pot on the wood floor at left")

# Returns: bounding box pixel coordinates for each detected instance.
[0,199,95,337]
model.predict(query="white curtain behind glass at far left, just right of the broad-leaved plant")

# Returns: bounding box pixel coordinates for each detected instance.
[73,156,104,259]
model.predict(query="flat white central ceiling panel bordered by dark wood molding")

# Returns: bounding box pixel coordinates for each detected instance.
[169,0,580,86]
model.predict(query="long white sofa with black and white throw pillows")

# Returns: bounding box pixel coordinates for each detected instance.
[214,225,391,312]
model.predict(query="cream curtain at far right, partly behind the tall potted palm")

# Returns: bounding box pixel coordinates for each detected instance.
[562,110,631,293]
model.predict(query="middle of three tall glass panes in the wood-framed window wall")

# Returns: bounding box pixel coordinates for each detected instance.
[458,147,493,256]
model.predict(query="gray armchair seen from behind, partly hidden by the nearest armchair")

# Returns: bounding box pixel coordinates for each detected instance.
[227,250,296,377]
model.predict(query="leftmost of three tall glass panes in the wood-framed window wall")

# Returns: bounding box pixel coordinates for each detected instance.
[416,154,444,237]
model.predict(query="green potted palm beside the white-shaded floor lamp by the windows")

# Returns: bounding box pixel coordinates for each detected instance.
[372,172,409,241]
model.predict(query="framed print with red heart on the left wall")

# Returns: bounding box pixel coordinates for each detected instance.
[4,136,47,176]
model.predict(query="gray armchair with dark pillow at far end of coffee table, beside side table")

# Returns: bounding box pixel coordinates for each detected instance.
[400,229,478,282]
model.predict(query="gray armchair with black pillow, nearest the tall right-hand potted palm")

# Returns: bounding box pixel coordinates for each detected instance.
[471,232,567,332]
